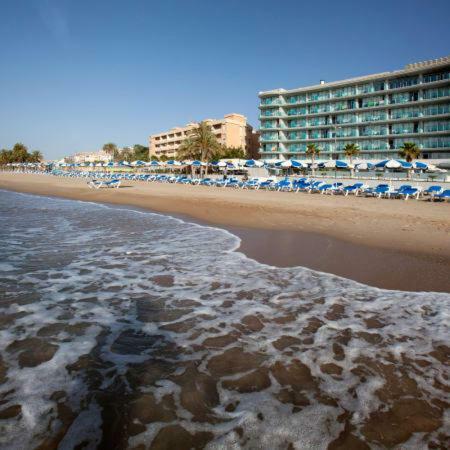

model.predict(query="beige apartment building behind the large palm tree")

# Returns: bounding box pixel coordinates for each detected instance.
[149,113,259,159]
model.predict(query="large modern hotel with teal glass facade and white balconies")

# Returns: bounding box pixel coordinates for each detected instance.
[259,57,450,164]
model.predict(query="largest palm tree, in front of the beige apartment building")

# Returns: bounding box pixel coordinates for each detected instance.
[177,122,221,175]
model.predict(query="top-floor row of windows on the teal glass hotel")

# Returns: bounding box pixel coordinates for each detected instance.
[261,71,450,105]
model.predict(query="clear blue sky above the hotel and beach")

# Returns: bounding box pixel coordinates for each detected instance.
[0,0,450,158]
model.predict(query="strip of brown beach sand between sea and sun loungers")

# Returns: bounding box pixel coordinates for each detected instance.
[0,172,450,292]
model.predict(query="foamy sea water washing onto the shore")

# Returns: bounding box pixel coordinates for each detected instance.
[0,191,450,449]
